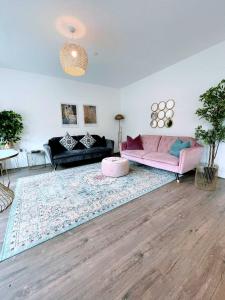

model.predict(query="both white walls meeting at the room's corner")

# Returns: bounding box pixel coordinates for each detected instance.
[0,42,225,177]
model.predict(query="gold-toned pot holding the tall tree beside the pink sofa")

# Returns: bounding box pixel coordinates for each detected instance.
[195,164,218,191]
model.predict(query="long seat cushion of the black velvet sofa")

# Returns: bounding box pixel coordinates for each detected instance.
[53,147,111,159]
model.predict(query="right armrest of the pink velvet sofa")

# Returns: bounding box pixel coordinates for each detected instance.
[179,146,203,174]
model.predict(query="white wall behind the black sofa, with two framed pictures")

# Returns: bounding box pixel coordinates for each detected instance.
[0,69,120,166]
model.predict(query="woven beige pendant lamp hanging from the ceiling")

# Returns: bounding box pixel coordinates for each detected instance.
[60,25,88,76]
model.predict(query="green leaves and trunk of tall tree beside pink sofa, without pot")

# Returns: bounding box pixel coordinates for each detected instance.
[195,79,225,168]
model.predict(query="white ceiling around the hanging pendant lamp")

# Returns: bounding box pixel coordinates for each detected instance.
[0,0,225,88]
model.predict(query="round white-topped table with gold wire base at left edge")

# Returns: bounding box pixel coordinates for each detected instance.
[0,149,18,212]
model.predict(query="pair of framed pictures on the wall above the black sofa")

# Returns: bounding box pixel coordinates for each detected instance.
[61,103,97,126]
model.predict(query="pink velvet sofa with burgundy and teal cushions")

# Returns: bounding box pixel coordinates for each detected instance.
[120,135,203,182]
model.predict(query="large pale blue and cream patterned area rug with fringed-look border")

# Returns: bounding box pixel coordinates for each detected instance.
[0,163,174,260]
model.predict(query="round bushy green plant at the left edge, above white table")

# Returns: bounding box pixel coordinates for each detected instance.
[0,110,23,149]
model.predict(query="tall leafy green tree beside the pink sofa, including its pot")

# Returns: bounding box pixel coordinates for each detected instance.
[195,79,225,191]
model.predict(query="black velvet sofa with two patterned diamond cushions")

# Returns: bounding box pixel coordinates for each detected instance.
[43,135,114,169]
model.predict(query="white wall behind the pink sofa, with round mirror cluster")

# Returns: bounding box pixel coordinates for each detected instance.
[121,42,225,177]
